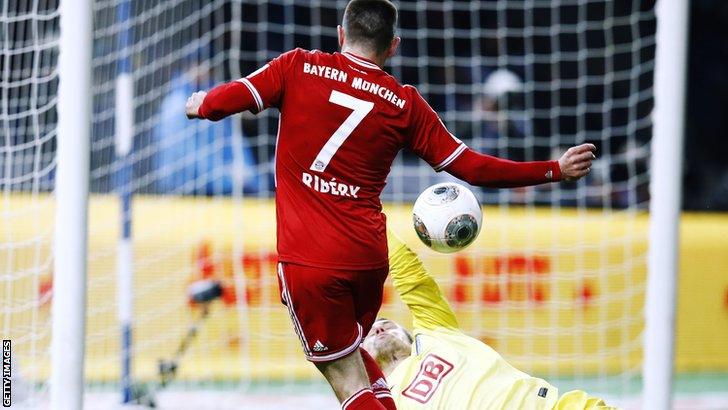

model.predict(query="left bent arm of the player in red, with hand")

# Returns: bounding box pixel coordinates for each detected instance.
[185,49,302,121]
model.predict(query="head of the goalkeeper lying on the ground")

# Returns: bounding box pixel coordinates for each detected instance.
[361,318,414,374]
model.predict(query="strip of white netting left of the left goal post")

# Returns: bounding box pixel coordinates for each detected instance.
[0,1,58,401]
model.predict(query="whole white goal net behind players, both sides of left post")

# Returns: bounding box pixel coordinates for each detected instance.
[0,0,655,408]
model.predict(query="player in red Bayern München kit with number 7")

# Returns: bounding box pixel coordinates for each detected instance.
[186,0,595,409]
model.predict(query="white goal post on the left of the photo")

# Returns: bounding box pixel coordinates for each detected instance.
[50,0,93,410]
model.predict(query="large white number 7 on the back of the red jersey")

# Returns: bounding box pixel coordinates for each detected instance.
[310,90,374,172]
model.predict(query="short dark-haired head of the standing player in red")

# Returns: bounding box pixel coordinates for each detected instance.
[338,0,400,66]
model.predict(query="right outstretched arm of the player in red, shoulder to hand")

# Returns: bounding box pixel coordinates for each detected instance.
[408,89,596,188]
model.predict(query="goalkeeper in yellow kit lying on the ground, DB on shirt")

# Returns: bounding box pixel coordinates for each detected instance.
[362,232,613,410]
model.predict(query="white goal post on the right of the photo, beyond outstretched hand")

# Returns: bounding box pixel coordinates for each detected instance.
[642,0,690,409]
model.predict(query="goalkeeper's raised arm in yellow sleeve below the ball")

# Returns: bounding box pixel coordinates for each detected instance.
[387,230,458,329]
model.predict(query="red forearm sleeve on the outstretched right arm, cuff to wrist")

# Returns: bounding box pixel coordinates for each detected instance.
[445,148,561,188]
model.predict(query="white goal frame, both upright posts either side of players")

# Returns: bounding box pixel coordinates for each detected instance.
[50,0,689,409]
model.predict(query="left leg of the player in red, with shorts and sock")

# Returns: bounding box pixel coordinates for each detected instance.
[278,264,384,410]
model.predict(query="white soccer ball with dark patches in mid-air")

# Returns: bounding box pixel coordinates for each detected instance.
[412,182,483,253]
